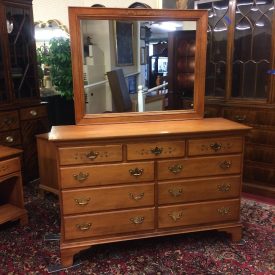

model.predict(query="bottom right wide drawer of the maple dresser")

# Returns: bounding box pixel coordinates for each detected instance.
[158,199,240,228]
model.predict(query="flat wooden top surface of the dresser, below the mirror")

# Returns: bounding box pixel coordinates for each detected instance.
[48,118,251,141]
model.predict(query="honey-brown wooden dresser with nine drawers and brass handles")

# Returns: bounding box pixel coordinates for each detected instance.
[39,118,250,266]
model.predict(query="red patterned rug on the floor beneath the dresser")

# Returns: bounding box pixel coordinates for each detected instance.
[0,185,275,275]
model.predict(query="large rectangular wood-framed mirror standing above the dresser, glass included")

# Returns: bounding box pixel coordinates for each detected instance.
[69,7,207,124]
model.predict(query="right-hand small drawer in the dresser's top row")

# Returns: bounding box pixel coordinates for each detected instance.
[188,137,243,156]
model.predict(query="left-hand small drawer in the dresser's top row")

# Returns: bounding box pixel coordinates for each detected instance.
[58,145,122,165]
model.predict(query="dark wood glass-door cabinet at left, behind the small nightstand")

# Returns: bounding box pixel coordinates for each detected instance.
[0,0,49,181]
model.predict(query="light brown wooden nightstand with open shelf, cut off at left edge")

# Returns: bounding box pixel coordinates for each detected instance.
[0,146,28,225]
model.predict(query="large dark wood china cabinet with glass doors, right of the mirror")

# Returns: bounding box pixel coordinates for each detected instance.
[198,0,275,198]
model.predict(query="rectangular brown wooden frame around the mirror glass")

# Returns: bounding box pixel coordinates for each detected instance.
[69,7,208,125]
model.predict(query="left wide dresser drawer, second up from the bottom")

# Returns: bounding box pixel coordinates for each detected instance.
[62,183,154,215]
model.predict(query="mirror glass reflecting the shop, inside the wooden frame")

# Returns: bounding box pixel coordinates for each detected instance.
[80,19,197,114]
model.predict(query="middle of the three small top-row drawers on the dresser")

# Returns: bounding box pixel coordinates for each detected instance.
[127,140,185,160]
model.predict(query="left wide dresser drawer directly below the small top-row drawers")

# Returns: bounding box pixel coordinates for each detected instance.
[60,161,154,188]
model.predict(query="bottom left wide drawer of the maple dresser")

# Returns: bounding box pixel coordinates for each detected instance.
[64,208,154,240]
